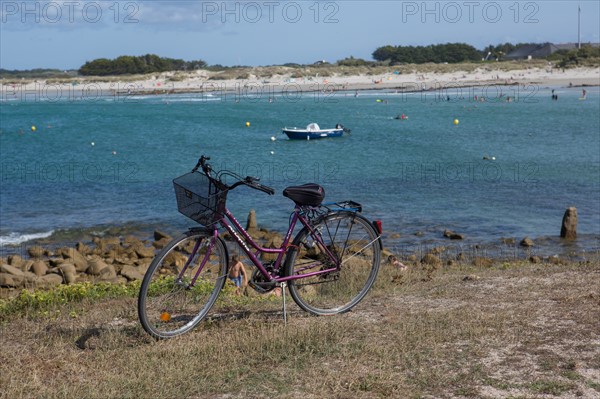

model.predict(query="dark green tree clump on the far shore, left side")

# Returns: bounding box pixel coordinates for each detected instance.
[79,54,206,76]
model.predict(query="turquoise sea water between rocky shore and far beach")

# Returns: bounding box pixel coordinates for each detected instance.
[0,86,600,256]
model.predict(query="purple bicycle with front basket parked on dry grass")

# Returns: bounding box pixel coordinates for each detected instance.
[138,156,383,339]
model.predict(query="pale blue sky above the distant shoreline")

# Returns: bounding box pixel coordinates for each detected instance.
[0,0,600,70]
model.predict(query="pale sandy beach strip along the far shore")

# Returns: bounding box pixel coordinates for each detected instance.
[0,63,600,101]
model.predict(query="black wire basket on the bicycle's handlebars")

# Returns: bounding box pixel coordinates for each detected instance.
[173,172,227,226]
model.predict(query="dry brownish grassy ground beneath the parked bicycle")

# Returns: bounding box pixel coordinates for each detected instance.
[0,261,600,399]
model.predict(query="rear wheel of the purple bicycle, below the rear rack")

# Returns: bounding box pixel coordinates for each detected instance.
[285,211,381,315]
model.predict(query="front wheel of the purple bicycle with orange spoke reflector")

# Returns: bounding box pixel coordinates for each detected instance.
[138,230,228,338]
